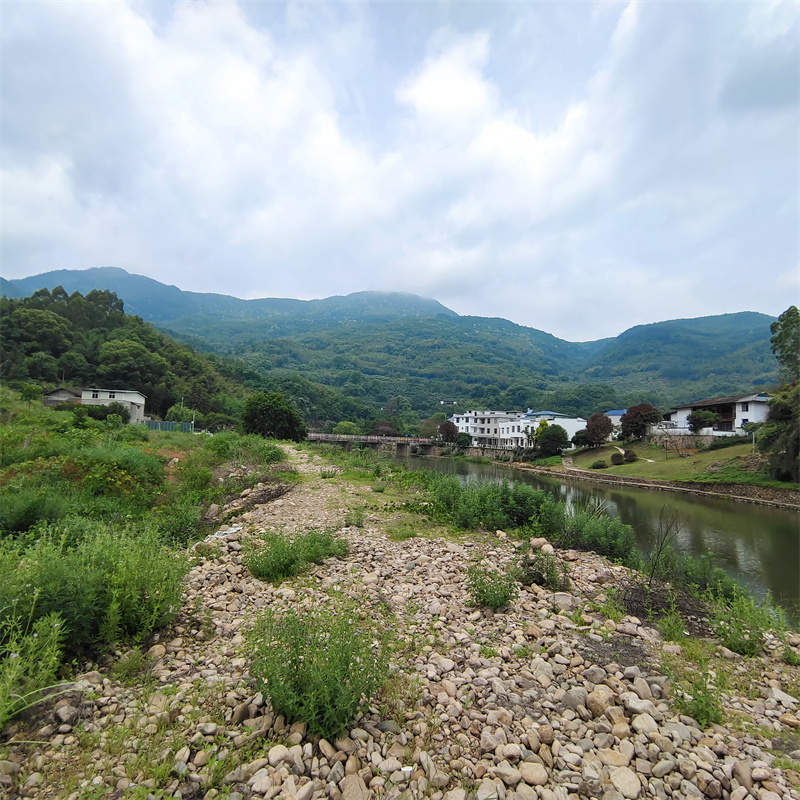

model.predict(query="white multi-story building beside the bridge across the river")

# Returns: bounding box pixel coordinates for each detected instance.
[450,409,586,450]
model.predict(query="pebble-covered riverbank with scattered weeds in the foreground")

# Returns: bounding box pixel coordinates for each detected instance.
[0,448,800,800]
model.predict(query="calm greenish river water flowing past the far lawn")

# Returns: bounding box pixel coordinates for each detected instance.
[401,456,800,621]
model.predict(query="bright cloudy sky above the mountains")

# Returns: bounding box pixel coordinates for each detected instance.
[0,0,800,341]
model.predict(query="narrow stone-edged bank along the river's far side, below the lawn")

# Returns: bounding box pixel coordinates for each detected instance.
[506,461,800,510]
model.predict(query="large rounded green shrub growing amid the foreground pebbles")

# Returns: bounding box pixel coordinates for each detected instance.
[248,602,386,741]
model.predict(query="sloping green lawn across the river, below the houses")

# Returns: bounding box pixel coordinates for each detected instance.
[572,444,797,489]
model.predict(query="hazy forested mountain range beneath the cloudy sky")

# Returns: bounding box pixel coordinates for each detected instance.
[0,268,777,419]
